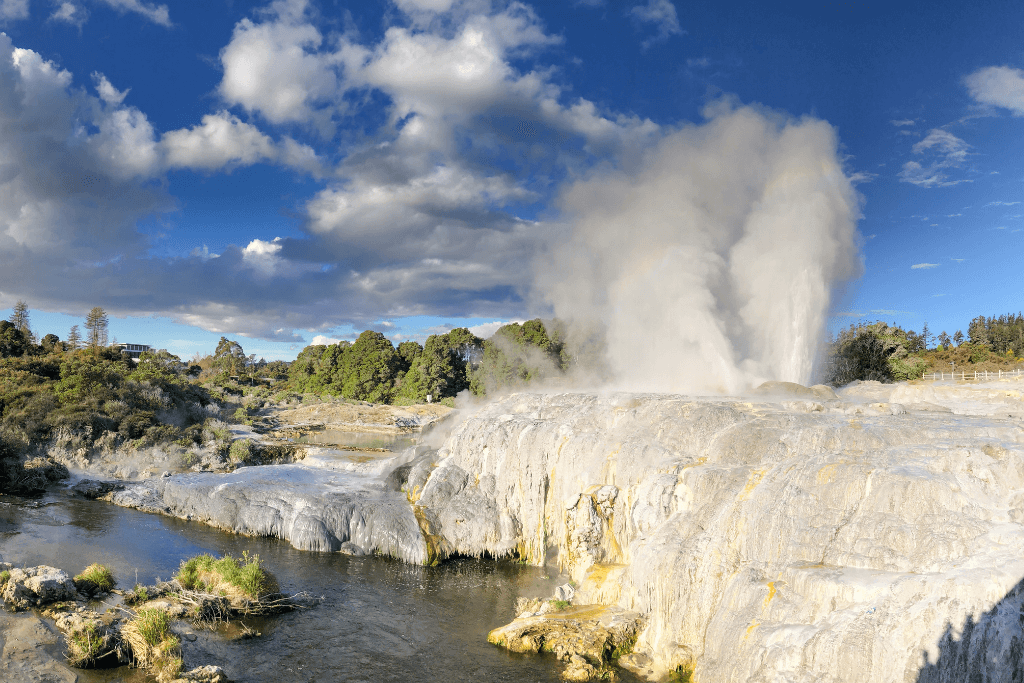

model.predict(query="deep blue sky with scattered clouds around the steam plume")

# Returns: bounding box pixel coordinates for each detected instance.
[0,0,1024,359]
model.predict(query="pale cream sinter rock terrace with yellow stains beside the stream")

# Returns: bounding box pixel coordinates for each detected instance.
[111,382,1024,683]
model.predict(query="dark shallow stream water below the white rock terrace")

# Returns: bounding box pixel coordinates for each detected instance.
[0,492,635,683]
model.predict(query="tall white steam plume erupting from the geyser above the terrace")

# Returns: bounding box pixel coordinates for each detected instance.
[538,102,860,393]
